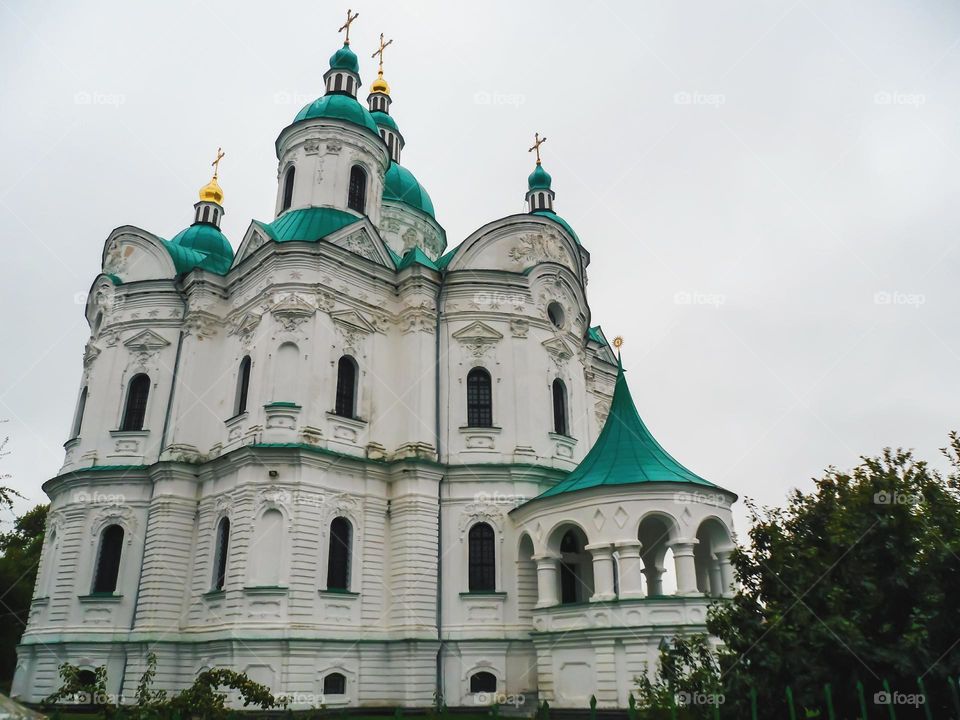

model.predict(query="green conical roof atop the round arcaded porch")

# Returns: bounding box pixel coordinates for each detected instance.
[535,365,716,499]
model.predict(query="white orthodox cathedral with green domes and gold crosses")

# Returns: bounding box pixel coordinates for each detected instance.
[13,16,736,708]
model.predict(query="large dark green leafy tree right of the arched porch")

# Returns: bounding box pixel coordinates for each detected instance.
[641,433,960,717]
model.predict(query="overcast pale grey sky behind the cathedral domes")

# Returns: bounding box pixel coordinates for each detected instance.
[0,0,960,532]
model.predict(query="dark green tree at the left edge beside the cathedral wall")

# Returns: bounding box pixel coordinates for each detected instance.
[0,500,48,693]
